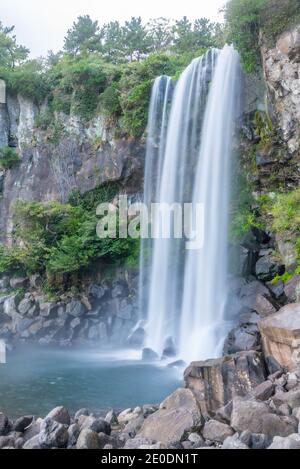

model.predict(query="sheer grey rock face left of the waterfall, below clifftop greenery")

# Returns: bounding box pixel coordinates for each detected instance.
[0,95,145,243]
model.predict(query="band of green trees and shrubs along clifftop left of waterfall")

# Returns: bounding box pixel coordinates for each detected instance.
[0,16,221,132]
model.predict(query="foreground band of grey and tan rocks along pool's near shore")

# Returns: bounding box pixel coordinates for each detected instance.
[0,357,300,450]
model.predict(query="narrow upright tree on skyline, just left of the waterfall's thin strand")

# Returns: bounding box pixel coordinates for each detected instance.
[123,17,150,61]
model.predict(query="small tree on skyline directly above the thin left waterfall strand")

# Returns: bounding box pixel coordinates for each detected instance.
[147,18,173,52]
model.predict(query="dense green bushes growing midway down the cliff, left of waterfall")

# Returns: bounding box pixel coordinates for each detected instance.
[0,184,139,291]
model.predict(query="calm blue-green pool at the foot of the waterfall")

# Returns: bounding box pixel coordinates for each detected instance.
[0,348,182,418]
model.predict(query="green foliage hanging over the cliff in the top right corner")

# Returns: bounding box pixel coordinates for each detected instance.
[225,0,300,73]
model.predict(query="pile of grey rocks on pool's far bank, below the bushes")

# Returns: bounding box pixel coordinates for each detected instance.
[0,268,142,346]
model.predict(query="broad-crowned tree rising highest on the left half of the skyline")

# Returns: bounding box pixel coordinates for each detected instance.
[64,15,101,55]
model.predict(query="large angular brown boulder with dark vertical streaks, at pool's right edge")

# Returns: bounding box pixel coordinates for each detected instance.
[184,351,267,417]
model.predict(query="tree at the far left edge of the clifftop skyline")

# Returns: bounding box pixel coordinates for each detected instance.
[0,21,29,68]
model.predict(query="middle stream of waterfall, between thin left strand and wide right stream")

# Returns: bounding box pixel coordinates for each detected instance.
[141,50,218,354]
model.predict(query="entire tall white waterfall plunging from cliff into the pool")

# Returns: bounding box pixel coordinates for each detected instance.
[141,46,240,360]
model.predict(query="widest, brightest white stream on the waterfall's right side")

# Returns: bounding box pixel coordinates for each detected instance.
[179,46,240,360]
